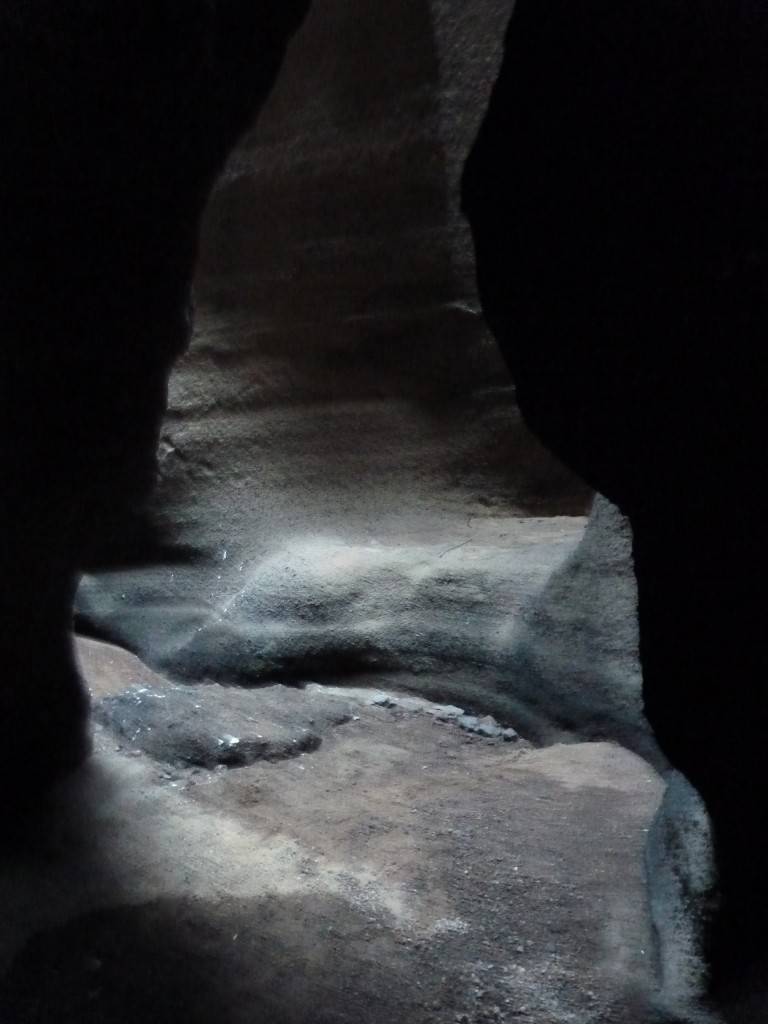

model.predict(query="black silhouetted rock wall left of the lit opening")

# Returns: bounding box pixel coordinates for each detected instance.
[0,0,308,811]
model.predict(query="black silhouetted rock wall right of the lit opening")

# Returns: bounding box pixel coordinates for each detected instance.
[464,0,768,999]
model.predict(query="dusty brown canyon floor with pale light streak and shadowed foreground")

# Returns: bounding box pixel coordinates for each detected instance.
[0,641,662,1024]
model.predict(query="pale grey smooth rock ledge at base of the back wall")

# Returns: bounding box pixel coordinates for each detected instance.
[80,505,664,767]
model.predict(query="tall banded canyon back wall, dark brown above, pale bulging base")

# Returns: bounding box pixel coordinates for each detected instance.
[73,0,588,720]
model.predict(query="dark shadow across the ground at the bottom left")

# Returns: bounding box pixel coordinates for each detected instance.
[0,897,450,1024]
